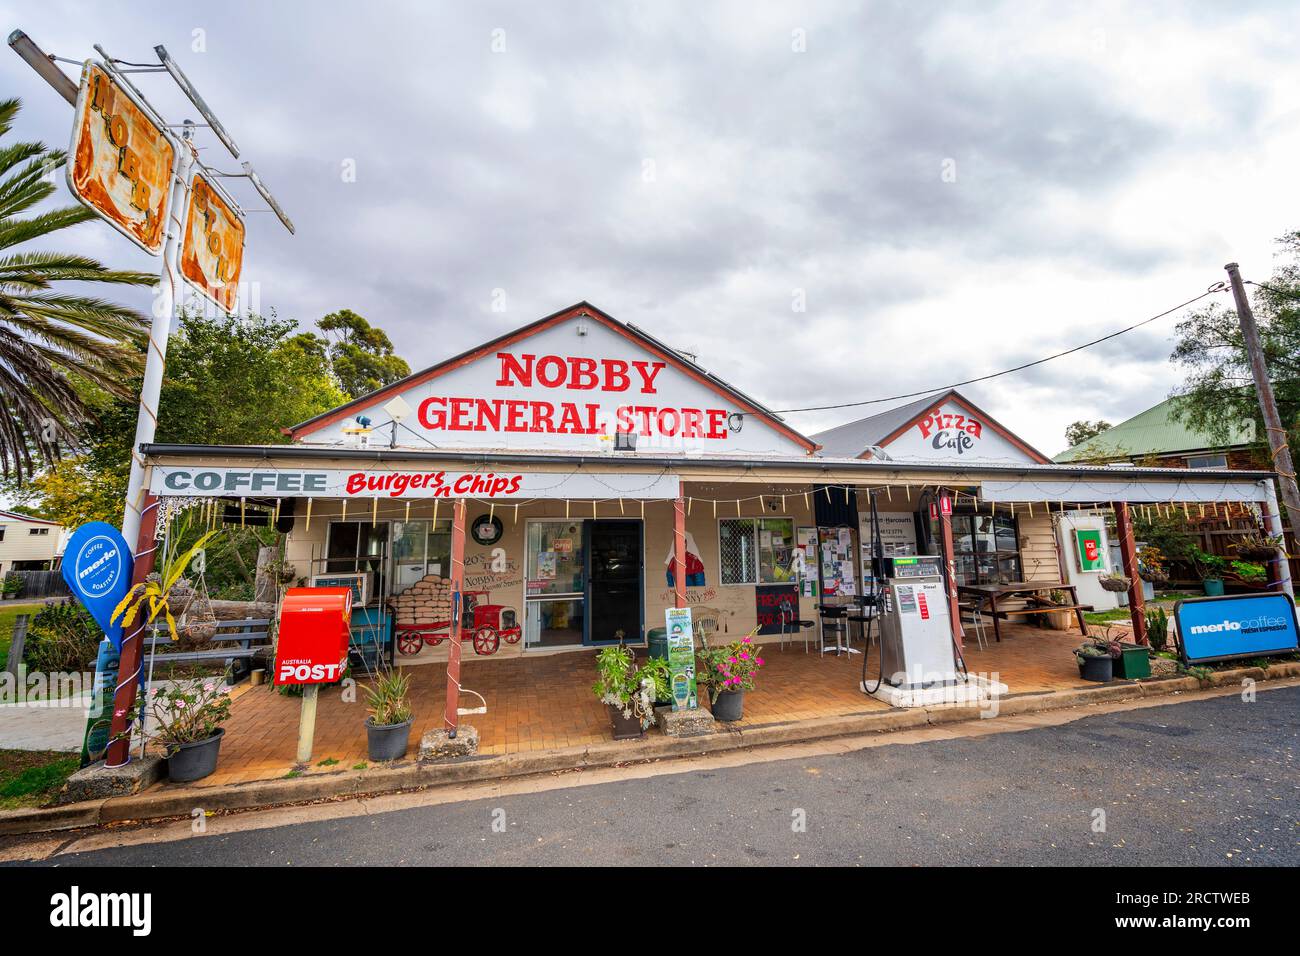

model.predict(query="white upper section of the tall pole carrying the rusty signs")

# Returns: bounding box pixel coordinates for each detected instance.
[122,120,195,551]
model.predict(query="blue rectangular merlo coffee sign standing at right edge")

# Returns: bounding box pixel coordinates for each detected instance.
[1174,592,1300,663]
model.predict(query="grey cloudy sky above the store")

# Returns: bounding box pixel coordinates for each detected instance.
[0,0,1300,454]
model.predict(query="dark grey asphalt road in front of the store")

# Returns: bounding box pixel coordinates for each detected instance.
[12,688,1300,866]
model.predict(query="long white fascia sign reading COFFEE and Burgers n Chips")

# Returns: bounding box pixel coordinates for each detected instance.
[150,466,680,501]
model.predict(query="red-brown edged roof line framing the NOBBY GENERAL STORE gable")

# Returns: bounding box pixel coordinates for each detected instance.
[282,299,818,451]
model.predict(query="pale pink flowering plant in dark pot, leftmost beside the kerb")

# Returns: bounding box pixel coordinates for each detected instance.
[146,678,230,783]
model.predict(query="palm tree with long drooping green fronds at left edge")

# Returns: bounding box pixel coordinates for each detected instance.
[0,99,157,483]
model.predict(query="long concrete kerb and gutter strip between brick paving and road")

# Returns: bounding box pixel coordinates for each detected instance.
[0,662,1300,834]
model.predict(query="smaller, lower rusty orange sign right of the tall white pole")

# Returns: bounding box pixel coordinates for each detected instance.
[181,173,244,313]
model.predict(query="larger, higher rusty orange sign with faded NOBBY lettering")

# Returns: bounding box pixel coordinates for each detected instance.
[68,60,177,255]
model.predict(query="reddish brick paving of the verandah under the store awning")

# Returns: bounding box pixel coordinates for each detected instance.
[178,624,1102,786]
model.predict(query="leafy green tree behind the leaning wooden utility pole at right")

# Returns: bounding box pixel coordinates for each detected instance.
[1171,232,1300,464]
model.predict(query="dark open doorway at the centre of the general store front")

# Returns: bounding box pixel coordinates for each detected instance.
[586,520,645,644]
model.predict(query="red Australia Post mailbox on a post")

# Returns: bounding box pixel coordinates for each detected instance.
[276,588,352,684]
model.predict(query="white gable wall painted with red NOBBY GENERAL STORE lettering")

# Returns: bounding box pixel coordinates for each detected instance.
[303,319,806,455]
